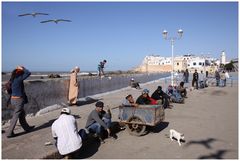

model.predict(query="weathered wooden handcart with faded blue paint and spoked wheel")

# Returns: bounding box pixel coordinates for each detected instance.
[119,105,165,136]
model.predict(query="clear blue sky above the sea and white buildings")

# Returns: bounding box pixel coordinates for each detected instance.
[2,2,238,71]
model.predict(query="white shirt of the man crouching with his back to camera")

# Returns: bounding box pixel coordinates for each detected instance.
[52,114,82,155]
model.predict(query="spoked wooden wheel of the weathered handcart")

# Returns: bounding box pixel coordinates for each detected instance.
[127,116,146,136]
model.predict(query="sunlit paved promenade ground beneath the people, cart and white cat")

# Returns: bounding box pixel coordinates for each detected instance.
[2,74,238,159]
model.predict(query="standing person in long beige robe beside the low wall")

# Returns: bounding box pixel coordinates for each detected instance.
[68,66,80,106]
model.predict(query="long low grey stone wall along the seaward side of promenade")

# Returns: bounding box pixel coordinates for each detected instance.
[2,73,170,120]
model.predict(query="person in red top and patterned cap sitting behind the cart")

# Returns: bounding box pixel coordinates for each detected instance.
[136,89,158,105]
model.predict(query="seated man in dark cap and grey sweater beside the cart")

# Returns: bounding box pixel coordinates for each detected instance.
[85,101,111,141]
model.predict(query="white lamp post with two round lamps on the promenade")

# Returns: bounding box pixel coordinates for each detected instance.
[162,29,183,86]
